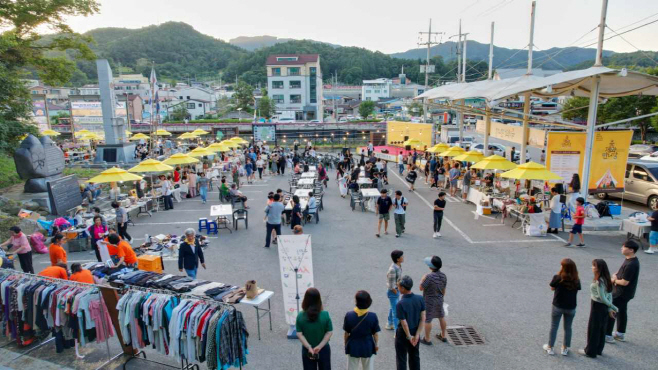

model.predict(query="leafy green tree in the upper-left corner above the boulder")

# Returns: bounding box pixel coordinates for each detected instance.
[0,0,99,151]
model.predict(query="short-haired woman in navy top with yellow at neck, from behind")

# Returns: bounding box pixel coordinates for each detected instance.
[343,290,381,370]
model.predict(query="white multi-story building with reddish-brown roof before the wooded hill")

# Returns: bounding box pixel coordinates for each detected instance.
[267,54,324,122]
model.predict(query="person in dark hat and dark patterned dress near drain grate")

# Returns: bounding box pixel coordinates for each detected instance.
[418,256,448,346]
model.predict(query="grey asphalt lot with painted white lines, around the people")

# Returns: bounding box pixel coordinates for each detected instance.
[0,160,658,370]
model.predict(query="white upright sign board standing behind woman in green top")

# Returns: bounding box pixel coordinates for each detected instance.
[278,235,313,325]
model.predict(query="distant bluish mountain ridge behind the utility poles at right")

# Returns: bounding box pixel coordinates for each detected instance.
[391,41,614,69]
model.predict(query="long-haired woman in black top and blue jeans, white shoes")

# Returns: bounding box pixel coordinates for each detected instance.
[544,258,581,356]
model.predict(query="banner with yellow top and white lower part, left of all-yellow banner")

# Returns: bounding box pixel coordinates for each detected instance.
[546,132,587,183]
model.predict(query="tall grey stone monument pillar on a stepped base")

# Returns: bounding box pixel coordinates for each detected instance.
[94,59,136,163]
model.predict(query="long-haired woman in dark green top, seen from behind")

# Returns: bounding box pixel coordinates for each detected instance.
[295,288,334,370]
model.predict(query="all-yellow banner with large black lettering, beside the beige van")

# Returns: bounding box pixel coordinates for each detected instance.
[587,131,633,193]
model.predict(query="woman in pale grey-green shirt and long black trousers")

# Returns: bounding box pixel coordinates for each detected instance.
[578,259,618,358]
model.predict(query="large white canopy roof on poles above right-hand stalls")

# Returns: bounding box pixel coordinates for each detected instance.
[416,67,658,102]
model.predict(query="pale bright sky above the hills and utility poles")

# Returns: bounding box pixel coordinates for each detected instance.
[61,0,658,53]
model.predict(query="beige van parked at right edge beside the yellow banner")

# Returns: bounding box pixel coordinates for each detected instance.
[597,160,658,209]
